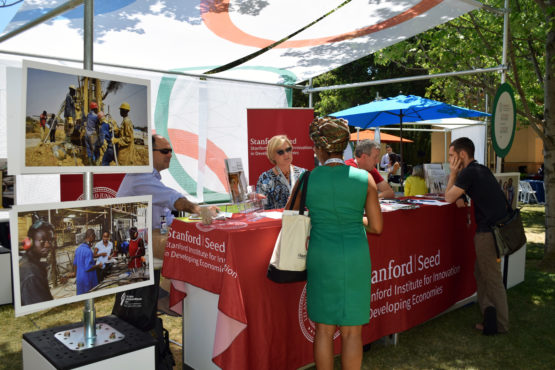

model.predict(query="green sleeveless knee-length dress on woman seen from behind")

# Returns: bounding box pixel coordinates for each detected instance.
[306,165,371,325]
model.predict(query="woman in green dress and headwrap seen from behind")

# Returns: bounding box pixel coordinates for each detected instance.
[286,117,383,370]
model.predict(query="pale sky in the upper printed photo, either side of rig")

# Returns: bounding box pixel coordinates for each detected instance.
[25,68,149,127]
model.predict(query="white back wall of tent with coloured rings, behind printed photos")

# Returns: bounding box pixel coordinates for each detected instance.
[0,60,288,203]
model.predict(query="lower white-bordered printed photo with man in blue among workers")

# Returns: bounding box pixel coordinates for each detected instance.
[10,196,154,316]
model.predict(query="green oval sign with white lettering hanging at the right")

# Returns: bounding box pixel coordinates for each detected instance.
[491,83,516,158]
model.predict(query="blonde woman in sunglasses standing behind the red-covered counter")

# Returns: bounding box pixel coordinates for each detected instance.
[256,135,306,209]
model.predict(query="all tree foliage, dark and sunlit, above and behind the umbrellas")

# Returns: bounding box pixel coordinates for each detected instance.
[298,0,555,261]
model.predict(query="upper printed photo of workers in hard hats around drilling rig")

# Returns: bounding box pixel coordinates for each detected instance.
[25,67,150,168]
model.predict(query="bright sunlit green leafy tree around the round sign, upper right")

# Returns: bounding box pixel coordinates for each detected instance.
[375,0,555,266]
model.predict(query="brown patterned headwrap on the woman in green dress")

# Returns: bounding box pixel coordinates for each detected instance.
[309,116,351,153]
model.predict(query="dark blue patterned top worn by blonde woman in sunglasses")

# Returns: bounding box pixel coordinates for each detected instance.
[256,166,306,209]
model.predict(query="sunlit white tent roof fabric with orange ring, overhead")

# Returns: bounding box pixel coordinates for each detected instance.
[0,0,481,84]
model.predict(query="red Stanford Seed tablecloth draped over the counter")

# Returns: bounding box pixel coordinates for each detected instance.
[162,205,476,369]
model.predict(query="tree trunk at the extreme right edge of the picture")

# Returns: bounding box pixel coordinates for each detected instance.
[543,2,555,267]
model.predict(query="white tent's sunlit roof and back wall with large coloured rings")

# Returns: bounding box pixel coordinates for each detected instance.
[0,0,481,201]
